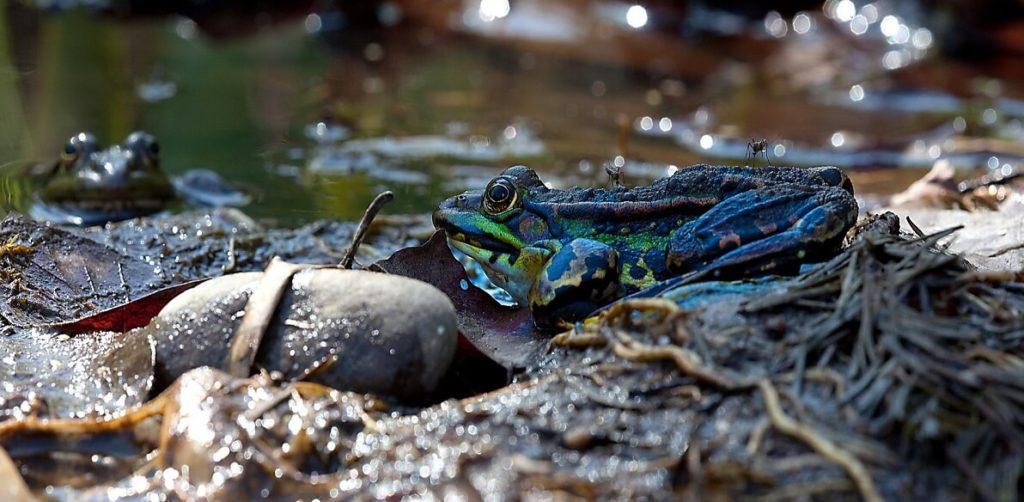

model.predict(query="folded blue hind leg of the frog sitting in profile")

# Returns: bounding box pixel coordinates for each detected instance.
[668,184,857,277]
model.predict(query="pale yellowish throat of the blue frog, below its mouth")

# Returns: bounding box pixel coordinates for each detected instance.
[449,238,551,306]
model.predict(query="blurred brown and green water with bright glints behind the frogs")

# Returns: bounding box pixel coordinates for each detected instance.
[0,0,1024,225]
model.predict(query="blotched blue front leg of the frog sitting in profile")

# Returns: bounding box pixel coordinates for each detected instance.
[529,239,620,325]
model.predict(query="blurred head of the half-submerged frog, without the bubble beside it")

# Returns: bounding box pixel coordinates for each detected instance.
[39,132,174,221]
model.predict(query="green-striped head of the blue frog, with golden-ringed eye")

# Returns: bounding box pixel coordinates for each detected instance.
[433,166,554,304]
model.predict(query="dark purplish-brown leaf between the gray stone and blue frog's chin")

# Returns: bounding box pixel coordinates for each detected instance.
[376,231,548,368]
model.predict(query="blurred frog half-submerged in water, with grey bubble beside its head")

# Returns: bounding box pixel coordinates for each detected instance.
[32,131,247,225]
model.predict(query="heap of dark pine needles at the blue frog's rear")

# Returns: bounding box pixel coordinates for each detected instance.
[746,213,1024,499]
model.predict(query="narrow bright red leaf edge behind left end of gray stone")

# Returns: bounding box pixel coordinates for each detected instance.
[47,279,206,334]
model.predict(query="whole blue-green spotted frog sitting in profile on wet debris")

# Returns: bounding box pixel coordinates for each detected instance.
[433,165,857,324]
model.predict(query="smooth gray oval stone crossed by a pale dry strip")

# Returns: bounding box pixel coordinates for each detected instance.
[142,269,458,401]
